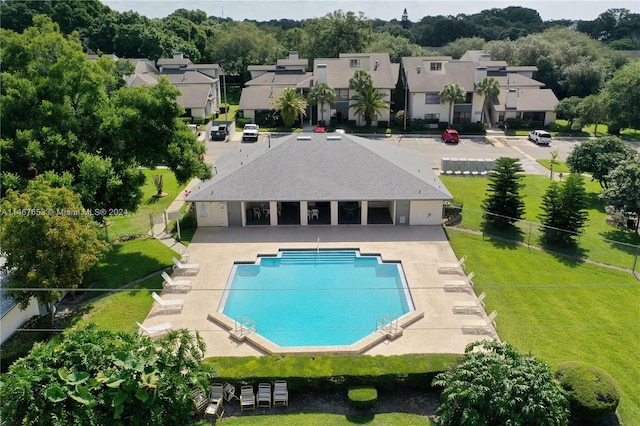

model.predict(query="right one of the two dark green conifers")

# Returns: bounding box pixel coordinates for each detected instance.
[539,174,588,244]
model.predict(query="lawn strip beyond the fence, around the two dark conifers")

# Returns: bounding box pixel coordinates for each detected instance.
[440,175,640,270]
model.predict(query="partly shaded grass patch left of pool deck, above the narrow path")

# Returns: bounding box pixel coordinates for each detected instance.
[87,238,176,289]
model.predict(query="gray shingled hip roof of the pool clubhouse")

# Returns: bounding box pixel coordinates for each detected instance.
[187,133,452,202]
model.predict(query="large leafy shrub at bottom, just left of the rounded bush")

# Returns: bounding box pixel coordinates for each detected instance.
[433,341,569,426]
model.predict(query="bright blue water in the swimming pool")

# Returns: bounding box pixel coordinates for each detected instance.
[221,250,412,347]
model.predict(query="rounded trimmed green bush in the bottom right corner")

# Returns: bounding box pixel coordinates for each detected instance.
[555,361,620,420]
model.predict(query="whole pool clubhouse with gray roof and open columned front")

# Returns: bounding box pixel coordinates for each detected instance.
[187,133,452,226]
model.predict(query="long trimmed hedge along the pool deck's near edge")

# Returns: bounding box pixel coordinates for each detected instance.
[206,354,461,392]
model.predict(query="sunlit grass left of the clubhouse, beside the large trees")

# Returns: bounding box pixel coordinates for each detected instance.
[105,169,184,241]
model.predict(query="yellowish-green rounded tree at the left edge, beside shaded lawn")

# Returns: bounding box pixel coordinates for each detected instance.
[0,177,105,322]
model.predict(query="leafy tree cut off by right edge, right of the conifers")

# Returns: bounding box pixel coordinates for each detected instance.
[601,154,640,232]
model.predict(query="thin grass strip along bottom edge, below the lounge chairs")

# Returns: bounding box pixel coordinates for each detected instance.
[199,413,436,426]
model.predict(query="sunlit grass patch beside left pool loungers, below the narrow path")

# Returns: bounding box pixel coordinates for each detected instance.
[75,275,163,332]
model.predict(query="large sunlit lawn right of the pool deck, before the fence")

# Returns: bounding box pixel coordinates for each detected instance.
[447,229,640,425]
